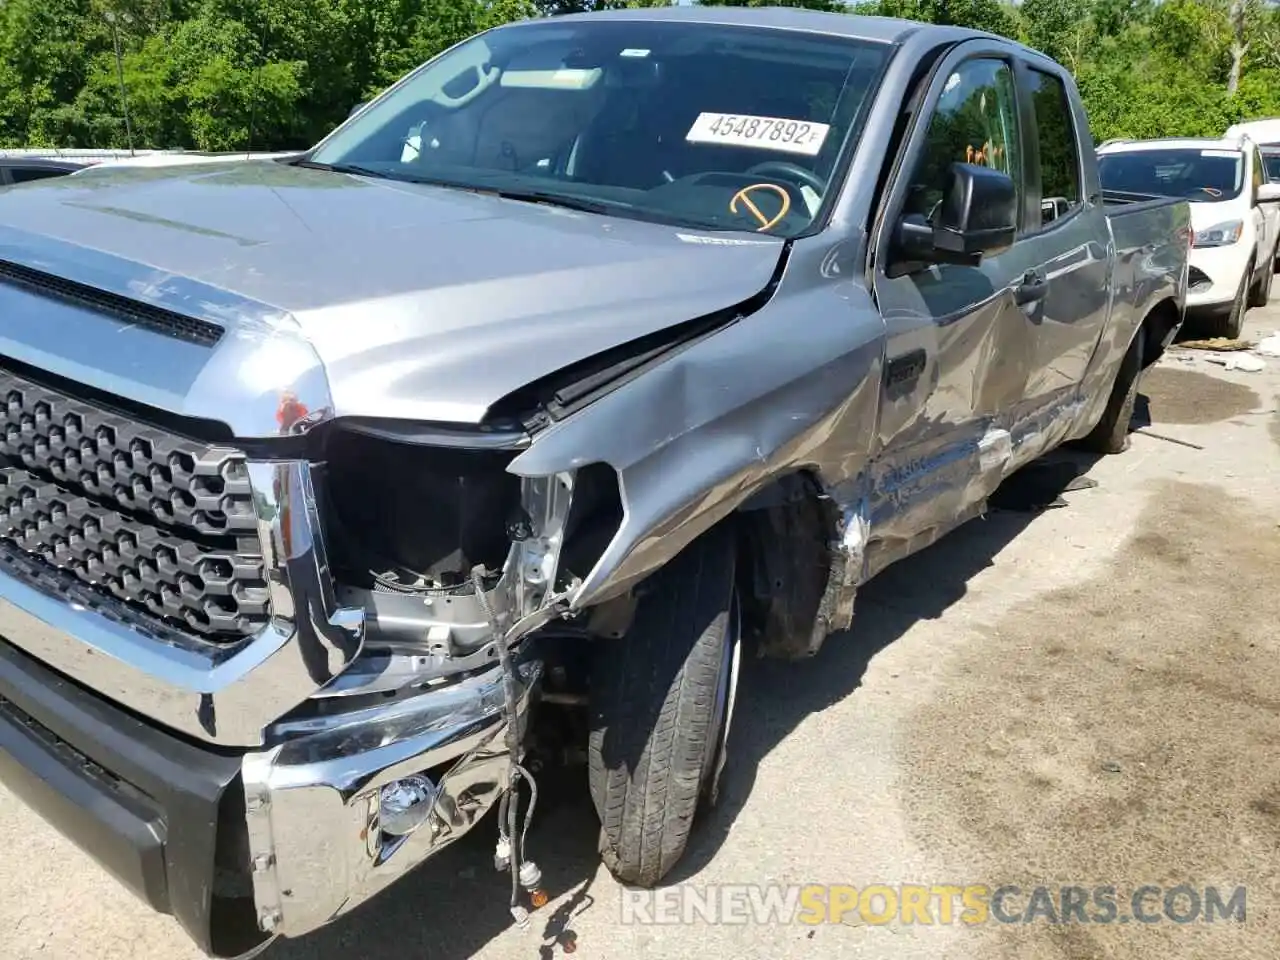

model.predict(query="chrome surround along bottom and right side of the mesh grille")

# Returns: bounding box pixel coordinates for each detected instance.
[0,461,364,746]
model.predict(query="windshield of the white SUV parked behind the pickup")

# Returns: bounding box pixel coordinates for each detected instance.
[1098,147,1244,204]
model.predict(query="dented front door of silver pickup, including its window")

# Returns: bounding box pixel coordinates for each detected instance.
[868,41,1033,572]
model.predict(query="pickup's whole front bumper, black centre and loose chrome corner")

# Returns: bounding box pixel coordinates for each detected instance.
[0,622,541,956]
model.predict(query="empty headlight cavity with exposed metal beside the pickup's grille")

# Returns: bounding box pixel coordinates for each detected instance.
[317,430,622,696]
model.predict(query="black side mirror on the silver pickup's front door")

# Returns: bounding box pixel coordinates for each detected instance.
[897,164,1018,266]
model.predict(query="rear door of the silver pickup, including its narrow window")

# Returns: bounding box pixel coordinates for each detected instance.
[1012,58,1114,462]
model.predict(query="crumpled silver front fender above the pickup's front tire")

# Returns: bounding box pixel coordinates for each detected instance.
[508,244,884,608]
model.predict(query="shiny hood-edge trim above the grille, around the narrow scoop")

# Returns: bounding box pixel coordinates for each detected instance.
[0,224,334,439]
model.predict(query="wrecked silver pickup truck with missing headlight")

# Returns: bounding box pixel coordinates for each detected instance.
[0,8,1190,956]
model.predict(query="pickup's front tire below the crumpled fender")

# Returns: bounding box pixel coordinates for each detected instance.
[588,524,740,887]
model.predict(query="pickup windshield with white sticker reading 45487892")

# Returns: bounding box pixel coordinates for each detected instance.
[303,20,891,237]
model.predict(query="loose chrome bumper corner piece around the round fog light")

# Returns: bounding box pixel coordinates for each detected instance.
[242,658,541,937]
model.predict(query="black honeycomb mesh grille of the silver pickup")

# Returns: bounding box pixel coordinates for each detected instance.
[0,369,270,644]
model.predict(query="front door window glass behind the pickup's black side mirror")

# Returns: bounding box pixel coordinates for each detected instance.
[904,58,1023,227]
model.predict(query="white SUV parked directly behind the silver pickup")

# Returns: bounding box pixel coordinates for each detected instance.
[1098,137,1280,338]
